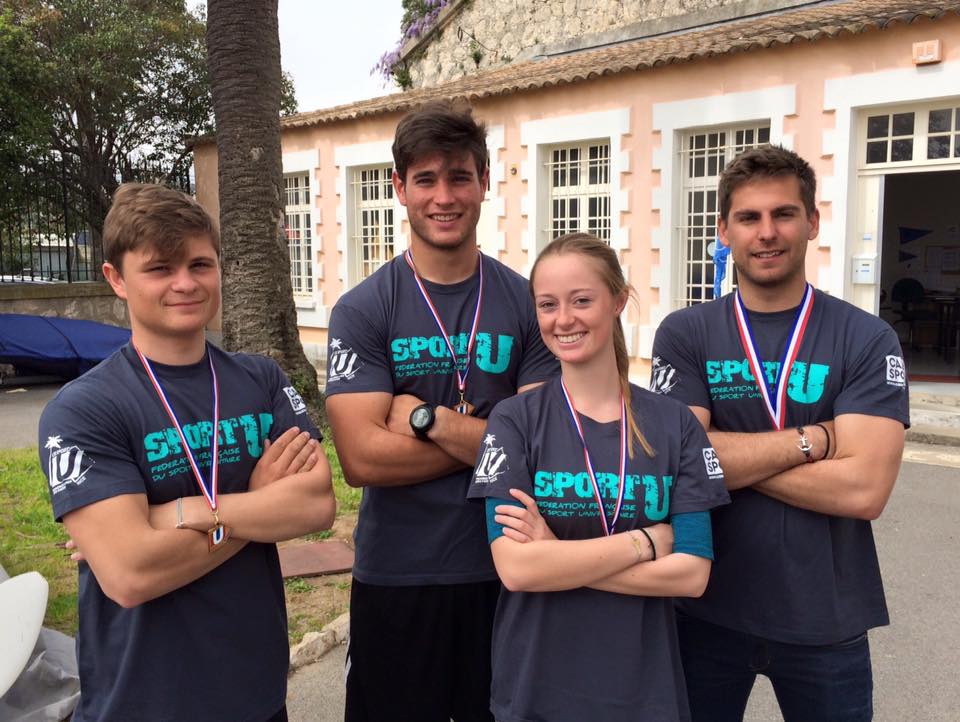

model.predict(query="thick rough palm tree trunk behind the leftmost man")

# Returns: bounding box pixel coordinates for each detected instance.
[207,0,322,423]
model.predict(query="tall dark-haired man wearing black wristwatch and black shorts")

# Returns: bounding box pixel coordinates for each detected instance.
[327,103,558,722]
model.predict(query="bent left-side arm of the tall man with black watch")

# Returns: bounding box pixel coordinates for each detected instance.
[327,391,466,487]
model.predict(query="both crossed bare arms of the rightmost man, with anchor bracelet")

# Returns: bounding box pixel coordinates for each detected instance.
[690,406,904,520]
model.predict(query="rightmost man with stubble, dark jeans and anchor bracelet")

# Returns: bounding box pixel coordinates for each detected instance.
[653,147,909,722]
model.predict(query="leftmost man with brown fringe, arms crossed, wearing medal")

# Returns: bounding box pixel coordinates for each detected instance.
[40,183,335,722]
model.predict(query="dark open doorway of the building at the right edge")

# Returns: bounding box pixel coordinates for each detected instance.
[880,171,960,383]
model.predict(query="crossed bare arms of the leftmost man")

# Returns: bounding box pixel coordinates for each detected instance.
[63,428,336,607]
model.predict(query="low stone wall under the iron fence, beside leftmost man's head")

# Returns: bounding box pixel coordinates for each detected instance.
[0,283,130,327]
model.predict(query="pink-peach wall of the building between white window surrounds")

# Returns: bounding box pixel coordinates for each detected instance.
[196,14,960,378]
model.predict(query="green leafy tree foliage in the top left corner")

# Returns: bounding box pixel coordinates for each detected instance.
[0,0,296,229]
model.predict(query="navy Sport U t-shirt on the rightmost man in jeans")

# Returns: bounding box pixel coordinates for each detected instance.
[652,291,910,644]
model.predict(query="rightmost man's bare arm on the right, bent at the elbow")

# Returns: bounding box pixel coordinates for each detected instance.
[752,414,904,520]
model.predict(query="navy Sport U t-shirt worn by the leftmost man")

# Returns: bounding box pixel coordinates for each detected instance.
[40,345,319,722]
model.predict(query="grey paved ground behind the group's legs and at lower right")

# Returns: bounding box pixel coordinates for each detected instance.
[288,444,960,722]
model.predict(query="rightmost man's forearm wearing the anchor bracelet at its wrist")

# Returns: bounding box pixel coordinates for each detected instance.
[690,406,836,491]
